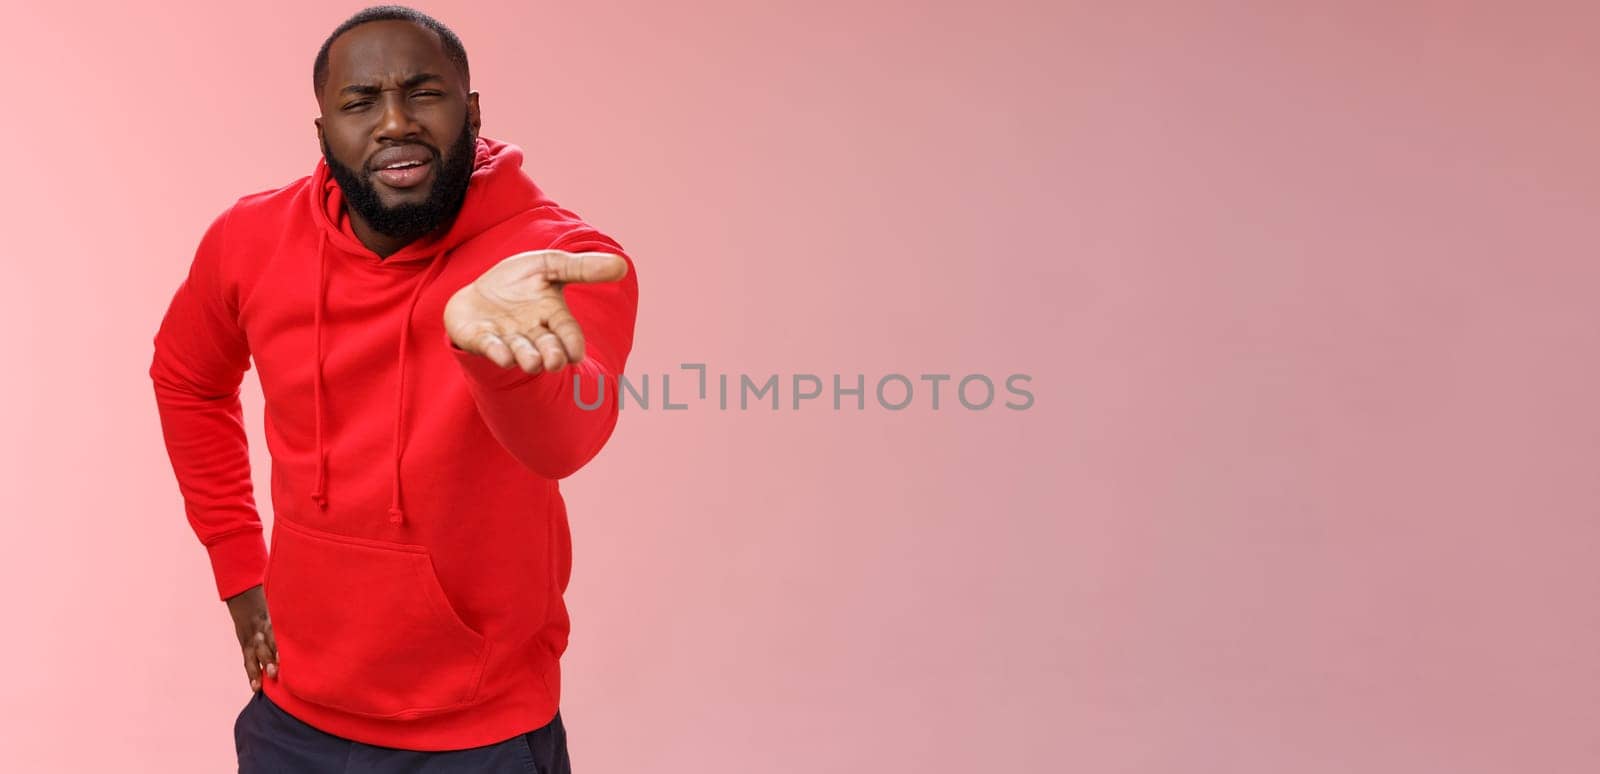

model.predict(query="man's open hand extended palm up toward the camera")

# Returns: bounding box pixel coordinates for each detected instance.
[445,249,627,374]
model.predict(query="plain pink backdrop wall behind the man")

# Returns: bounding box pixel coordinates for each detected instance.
[0,0,1600,774]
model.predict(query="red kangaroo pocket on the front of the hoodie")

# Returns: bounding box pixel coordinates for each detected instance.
[264,518,488,718]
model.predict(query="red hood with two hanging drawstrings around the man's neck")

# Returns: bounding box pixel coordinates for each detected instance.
[307,134,554,525]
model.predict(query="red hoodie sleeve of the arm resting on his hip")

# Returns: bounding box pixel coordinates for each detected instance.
[149,209,267,600]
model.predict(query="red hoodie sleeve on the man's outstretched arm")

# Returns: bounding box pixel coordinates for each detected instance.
[445,227,638,478]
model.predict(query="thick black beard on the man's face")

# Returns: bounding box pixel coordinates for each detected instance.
[322,123,478,243]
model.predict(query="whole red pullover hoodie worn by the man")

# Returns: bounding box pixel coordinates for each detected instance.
[149,138,638,750]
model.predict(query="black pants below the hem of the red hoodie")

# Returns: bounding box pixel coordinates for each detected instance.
[234,691,573,774]
